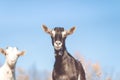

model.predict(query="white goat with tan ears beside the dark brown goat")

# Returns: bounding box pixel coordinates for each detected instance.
[0,47,25,80]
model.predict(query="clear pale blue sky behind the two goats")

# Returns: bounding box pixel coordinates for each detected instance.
[0,0,120,72]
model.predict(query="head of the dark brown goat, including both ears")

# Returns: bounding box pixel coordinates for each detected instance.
[42,25,75,51]
